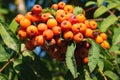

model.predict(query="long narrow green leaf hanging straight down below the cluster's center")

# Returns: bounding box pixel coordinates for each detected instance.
[66,43,78,78]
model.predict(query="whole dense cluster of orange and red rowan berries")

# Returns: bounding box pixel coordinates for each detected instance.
[15,2,110,64]
